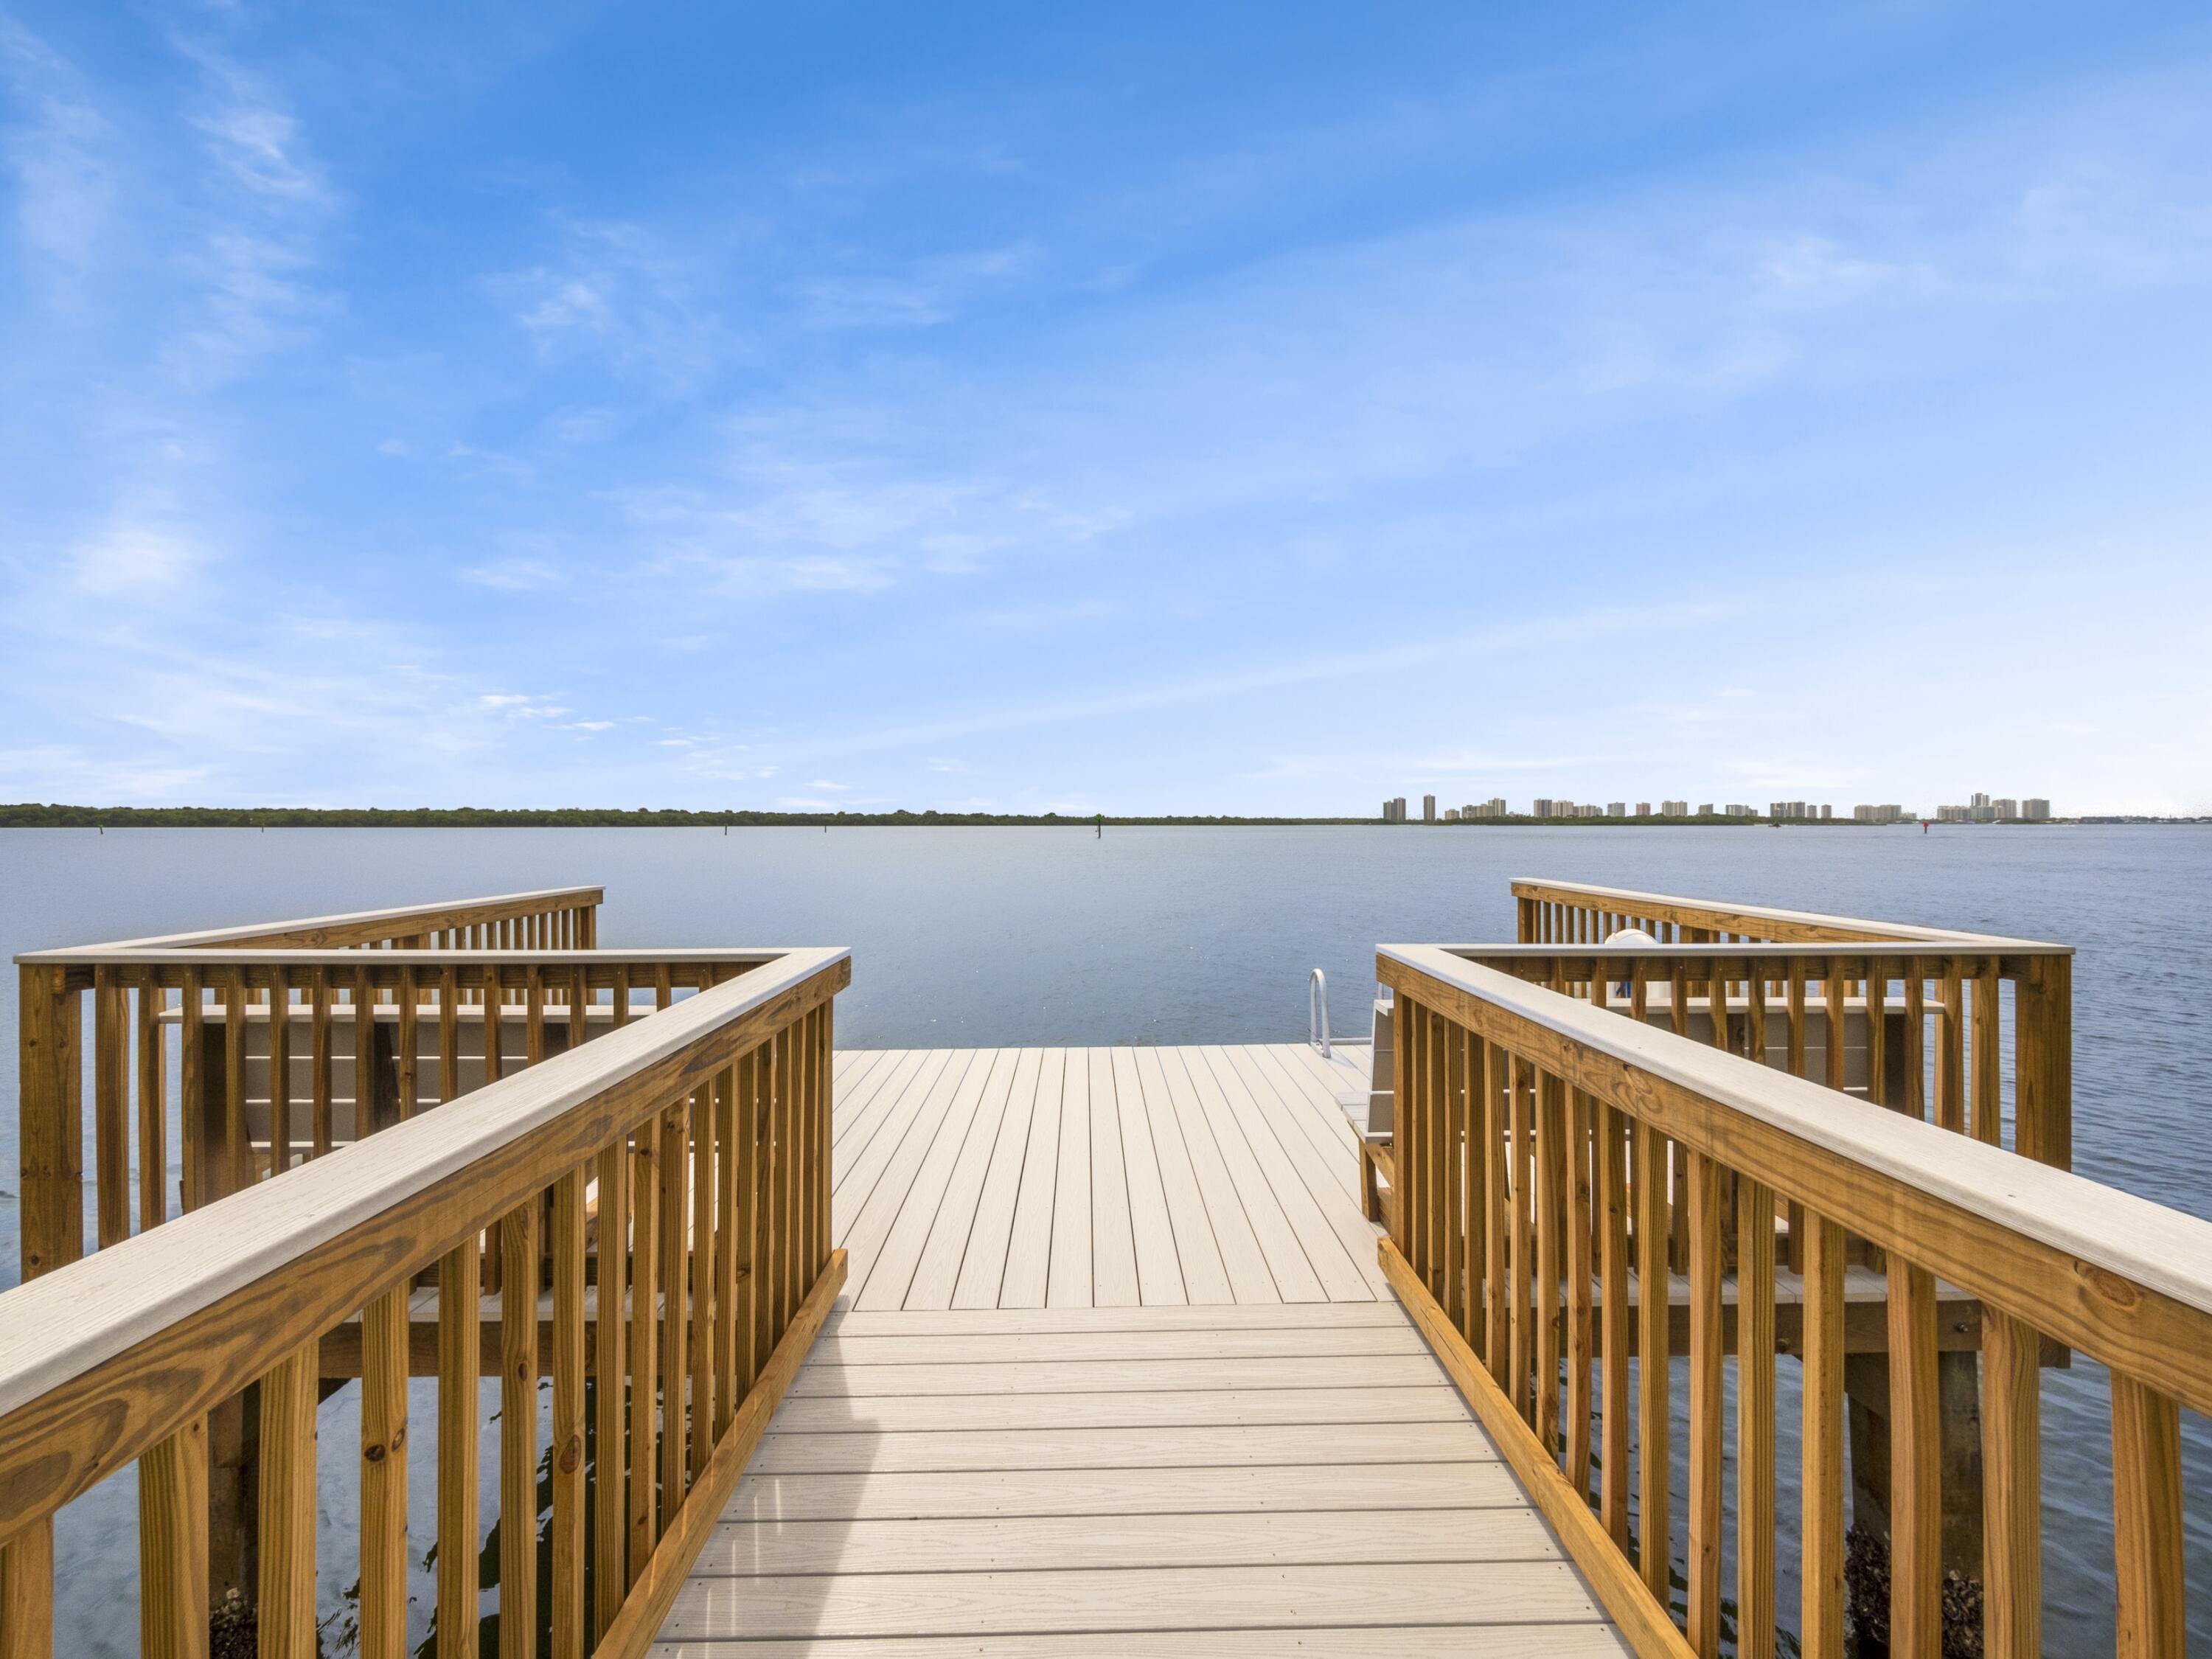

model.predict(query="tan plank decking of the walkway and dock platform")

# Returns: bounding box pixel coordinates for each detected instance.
[655,1044,1628,1659]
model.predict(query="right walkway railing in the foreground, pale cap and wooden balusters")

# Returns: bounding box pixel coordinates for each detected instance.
[1378,945,2212,1659]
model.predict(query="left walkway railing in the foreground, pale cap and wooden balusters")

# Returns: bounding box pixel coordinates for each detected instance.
[0,951,852,1659]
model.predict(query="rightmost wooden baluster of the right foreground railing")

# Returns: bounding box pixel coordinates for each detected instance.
[2112,1371,2188,1659]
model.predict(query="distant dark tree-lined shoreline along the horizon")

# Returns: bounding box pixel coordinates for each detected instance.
[0,803,2159,830]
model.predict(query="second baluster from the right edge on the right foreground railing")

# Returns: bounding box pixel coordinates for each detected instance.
[1982,1307,2035,1659]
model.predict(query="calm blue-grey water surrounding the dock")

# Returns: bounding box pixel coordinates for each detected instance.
[0,825,2212,1652]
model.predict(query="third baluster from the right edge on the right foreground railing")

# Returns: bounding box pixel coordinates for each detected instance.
[1889,1254,1942,1659]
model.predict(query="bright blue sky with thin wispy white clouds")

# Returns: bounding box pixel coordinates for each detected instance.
[0,0,2212,814]
